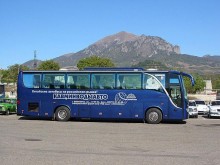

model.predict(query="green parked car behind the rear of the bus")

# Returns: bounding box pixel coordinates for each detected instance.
[0,98,17,115]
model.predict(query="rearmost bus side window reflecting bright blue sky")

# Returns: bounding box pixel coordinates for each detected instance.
[23,74,41,88]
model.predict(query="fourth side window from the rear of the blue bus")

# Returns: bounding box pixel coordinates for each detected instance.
[92,73,115,89]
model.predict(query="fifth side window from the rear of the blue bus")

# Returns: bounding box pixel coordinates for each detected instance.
[117,73,141,89]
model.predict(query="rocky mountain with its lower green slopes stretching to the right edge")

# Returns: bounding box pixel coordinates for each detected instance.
[23,31,220,74]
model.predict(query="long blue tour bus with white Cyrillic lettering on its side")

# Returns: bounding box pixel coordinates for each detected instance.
[17,68,194,124]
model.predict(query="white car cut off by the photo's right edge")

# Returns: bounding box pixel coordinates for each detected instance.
[208,100,220,118]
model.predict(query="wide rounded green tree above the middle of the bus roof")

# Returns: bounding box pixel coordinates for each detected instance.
[77,56,115,70]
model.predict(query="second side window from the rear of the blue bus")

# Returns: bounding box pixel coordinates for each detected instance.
[43,74,65,89]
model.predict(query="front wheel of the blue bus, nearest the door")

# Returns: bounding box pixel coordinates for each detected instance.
[145,108,162,124]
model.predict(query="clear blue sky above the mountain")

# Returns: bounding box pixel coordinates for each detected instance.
[0,0,220,69]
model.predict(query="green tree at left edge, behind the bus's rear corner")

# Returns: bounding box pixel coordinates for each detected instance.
[1,64,29,83]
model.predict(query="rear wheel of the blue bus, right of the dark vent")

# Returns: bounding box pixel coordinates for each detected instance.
[55,106,70,121]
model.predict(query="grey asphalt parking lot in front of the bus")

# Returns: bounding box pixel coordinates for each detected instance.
[0,115,220,165]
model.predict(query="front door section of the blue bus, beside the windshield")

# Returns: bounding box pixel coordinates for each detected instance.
[168,73,184,119]
